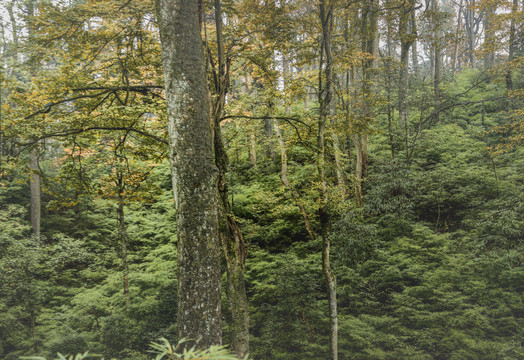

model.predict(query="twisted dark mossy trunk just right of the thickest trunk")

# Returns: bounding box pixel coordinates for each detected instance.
[213,0,249,359]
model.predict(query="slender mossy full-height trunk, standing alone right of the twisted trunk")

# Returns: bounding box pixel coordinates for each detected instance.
[317,0,338,360]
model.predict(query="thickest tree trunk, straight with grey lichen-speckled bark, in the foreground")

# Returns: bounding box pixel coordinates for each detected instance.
[156,0,222,348]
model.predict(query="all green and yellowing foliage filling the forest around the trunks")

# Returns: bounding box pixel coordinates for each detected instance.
[0,0,524,360]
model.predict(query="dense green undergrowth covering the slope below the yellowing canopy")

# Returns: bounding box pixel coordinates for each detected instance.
[0,65,524,360]
